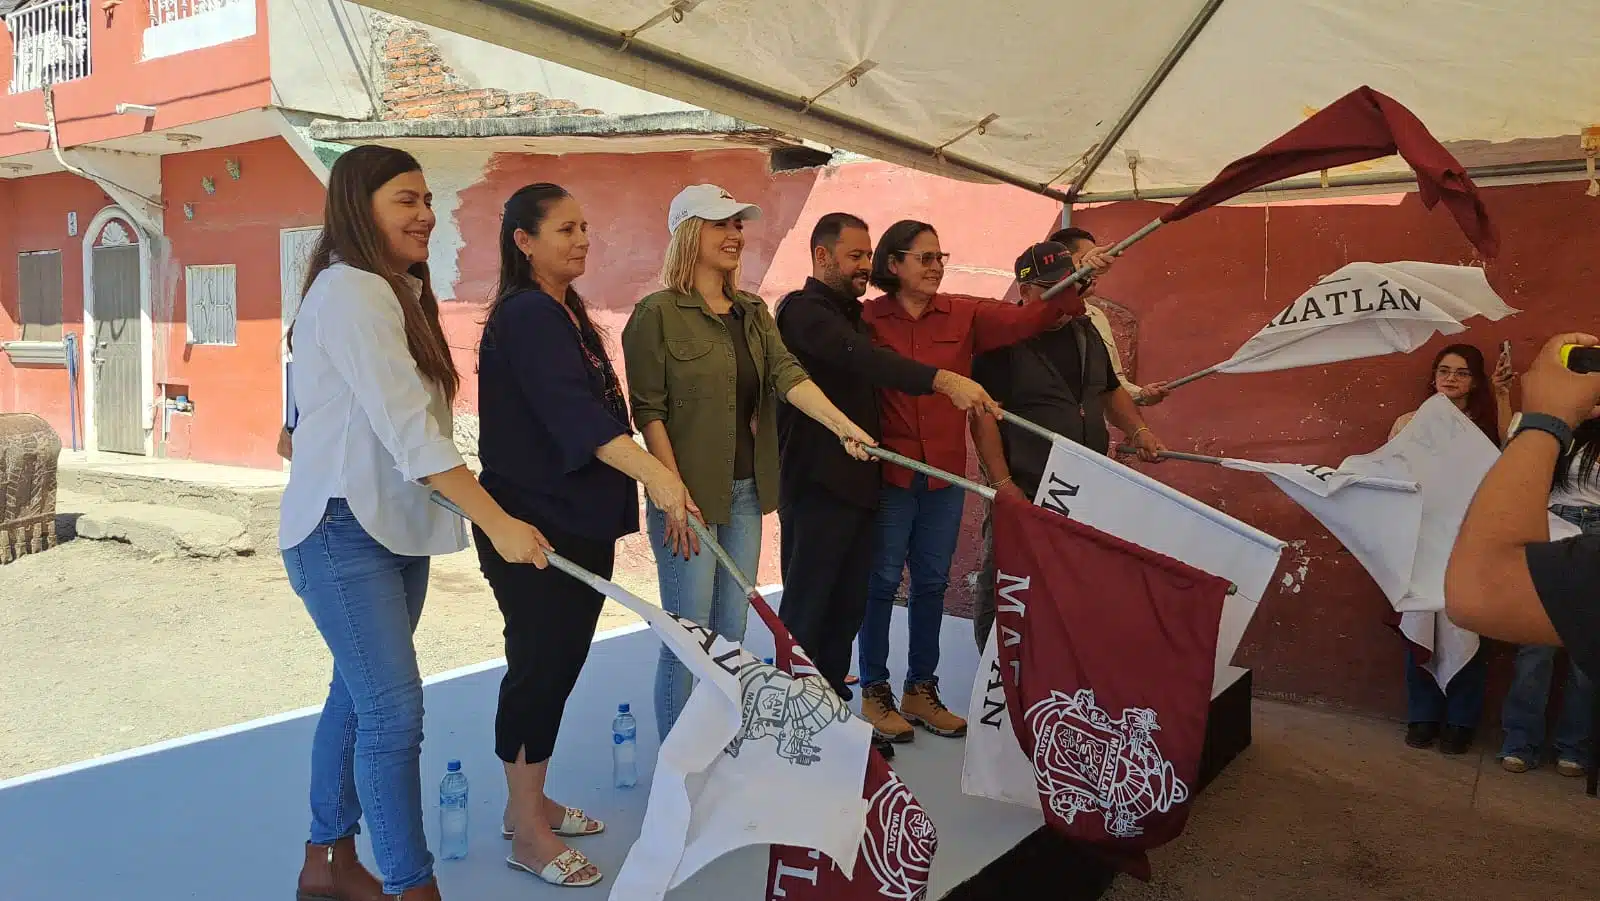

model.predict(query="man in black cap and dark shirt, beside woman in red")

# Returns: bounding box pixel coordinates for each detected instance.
[971,242,1162,648]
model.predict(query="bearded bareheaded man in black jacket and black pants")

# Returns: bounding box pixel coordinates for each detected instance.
[778,213,998,723]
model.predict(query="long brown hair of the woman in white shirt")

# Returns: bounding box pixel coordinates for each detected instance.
[288,144,461,400]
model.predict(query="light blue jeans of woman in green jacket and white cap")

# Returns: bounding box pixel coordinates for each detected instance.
[645,479,762,739]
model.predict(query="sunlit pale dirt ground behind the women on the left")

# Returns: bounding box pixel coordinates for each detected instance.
[0,528,658,779]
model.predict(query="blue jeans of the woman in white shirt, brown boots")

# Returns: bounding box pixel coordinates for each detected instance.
[283,498,434,895]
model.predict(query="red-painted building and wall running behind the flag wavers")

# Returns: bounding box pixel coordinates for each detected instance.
[0,0,1600,714]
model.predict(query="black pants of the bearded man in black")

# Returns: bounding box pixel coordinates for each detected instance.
[778,487,875,695]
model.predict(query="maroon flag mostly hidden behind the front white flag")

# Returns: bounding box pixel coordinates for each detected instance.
[750,595,934,901]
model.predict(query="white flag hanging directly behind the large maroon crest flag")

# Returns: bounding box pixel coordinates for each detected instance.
[962,442,1285,808]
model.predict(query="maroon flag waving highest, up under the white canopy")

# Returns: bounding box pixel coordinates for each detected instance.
[1162,86,1499,258]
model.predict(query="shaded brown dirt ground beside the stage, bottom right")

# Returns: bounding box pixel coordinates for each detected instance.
[1106,701,1600,901]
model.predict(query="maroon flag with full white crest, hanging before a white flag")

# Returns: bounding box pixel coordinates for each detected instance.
[994,495,1229,879]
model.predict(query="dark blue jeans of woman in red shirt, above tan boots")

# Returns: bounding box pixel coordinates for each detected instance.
[858,474,966,688]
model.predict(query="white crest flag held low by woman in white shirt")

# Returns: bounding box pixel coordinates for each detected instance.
[576,579,872,901]
